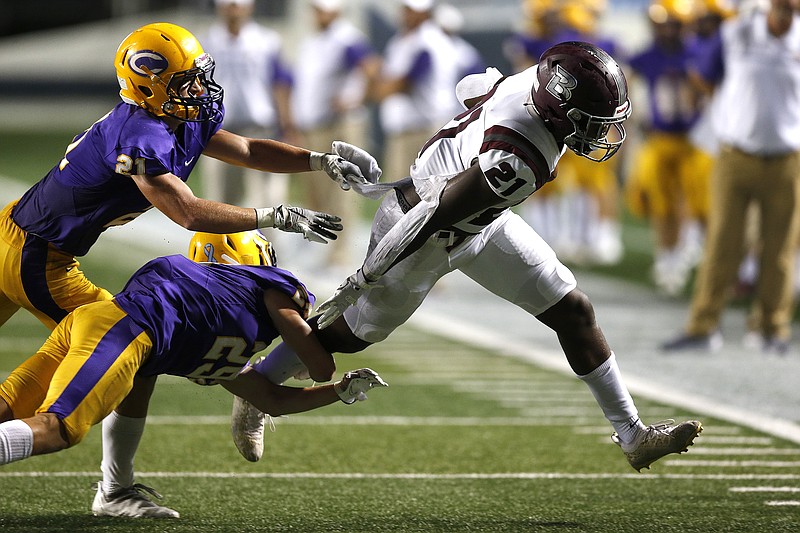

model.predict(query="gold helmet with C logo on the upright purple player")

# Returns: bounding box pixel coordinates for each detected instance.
[114,22,223,122]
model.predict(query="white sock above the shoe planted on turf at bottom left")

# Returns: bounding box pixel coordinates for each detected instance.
[100,411,146,494]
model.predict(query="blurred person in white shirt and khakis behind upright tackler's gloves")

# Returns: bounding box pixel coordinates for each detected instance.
[291,0,380,267]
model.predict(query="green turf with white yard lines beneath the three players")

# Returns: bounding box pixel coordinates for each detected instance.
[0,316,800,533]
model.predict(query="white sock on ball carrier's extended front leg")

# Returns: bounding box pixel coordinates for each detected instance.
[578,352,646,444]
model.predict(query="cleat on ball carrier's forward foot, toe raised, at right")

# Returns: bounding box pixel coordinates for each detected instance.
[611,420,703,472]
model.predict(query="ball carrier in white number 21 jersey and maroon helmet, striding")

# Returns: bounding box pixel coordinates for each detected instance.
[234,42,702,470]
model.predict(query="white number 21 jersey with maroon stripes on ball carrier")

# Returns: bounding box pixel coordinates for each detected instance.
[411,66,564,233]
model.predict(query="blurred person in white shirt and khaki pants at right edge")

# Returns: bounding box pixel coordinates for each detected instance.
[662,0,800,354]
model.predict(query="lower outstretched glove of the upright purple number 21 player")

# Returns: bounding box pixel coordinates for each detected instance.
[256,205,343,244]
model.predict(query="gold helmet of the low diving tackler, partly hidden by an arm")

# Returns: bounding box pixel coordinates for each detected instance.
[189,230,278,266]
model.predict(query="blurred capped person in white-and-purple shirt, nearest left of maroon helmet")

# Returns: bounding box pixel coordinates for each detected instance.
[372,0,458,183]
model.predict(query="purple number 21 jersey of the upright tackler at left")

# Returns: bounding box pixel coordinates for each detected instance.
[12,103,223,256]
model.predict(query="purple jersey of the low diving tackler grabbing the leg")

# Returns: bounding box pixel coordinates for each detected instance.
[115,255,314,379]
